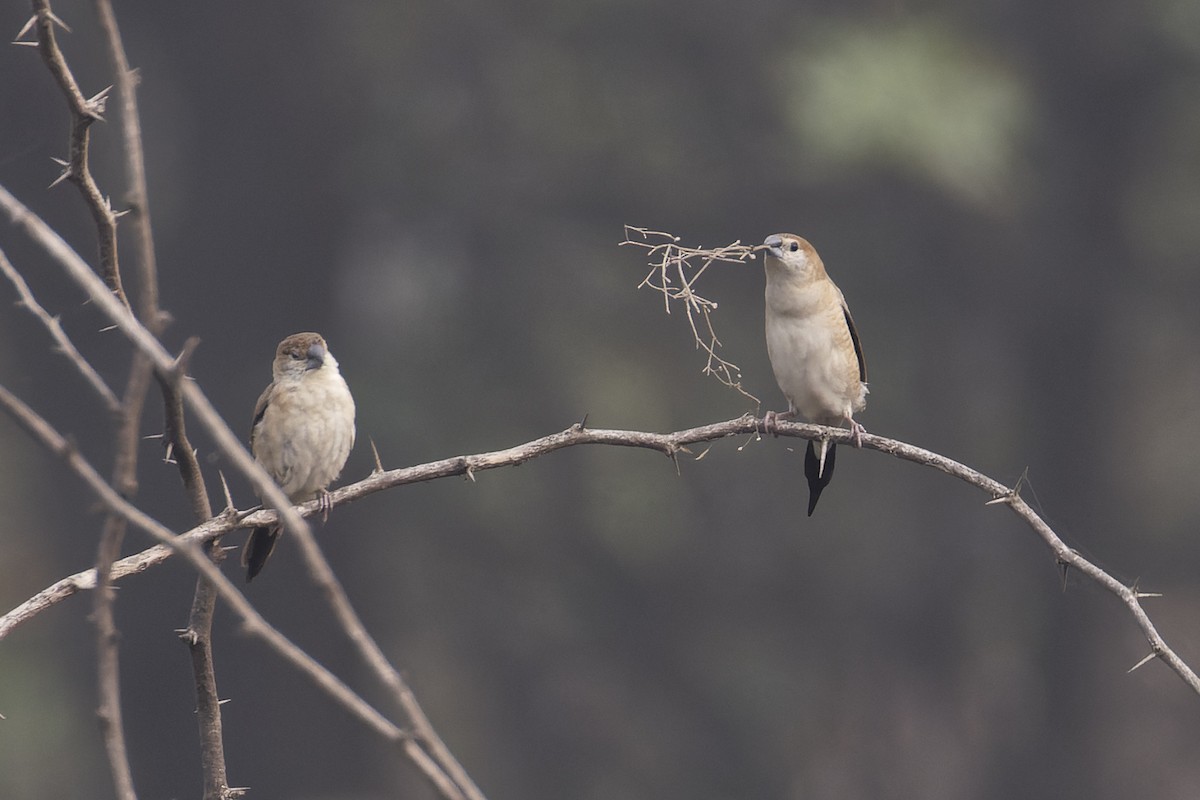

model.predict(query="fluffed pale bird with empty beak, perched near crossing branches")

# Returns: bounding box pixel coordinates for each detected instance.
[241,333,354,582]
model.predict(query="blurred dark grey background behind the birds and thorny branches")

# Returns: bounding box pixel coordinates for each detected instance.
[0,0,1200,800]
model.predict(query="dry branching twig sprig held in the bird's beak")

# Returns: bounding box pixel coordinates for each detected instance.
[620,225,762,405]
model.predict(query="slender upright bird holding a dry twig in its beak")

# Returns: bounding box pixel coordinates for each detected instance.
[763,234,868,517]
